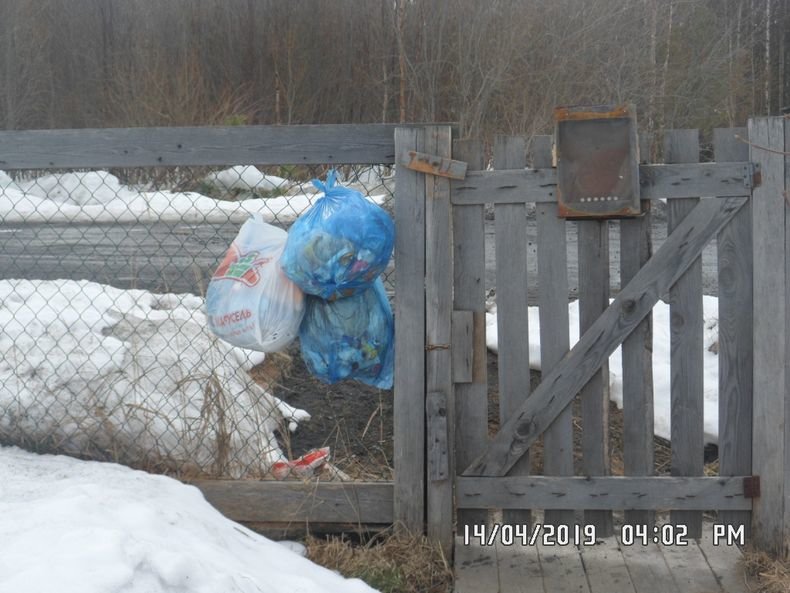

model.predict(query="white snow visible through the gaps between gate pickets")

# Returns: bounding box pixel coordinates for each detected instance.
[486,296,719,443]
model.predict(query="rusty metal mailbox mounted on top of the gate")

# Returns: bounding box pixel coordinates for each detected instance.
[554,105,641,218]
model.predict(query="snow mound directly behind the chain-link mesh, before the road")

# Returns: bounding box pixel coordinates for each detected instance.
[0,280,310,477]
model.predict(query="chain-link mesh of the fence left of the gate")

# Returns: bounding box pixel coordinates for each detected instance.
[0,166,394,479]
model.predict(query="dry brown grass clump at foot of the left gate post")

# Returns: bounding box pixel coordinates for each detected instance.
[305,528,453,593]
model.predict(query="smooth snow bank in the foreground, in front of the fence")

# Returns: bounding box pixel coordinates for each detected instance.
[0,447,373,593]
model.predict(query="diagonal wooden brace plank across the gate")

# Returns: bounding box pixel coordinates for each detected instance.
[463,198,746,476]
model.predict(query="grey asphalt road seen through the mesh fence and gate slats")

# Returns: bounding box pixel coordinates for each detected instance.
[0,210,717,303]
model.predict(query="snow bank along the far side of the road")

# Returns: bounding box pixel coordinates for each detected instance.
[0,166,388,223]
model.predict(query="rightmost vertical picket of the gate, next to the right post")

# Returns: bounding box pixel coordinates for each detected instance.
[713,128,754,532]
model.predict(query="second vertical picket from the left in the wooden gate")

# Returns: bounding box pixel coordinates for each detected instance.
[494,136,531,525]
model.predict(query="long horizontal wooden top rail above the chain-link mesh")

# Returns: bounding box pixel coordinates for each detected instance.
[0,124,412,169]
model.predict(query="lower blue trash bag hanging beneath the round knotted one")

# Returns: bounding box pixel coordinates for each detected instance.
[299,279,395,389]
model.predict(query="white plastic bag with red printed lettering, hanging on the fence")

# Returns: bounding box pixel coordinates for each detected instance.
[206,214,304,352]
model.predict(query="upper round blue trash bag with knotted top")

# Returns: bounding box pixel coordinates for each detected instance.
[280,170,395,300]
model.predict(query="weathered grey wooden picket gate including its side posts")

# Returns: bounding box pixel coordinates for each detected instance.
[395,118,786,552]
